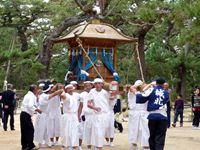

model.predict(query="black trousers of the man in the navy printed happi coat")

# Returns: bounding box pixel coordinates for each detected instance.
[148,120,168,150]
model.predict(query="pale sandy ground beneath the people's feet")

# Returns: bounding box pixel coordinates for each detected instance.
[0,111,200,150]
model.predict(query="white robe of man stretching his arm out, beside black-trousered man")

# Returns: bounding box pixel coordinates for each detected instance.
[34,93,49,144]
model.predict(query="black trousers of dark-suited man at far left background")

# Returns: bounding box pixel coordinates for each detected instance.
[3,109,14,131]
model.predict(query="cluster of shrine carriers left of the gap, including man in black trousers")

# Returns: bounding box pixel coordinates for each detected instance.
[20,78,118,150]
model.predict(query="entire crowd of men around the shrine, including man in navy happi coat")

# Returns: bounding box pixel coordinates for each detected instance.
[4,78,199,150]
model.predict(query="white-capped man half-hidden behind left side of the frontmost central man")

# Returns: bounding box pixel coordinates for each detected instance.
[79,81,94,150]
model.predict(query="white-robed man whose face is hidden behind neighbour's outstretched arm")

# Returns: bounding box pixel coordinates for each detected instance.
[47,83,63,145]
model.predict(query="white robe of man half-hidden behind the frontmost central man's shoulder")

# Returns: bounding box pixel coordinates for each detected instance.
[80,91,94,145]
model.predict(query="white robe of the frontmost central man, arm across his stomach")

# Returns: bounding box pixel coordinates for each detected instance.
[89,88,109,147]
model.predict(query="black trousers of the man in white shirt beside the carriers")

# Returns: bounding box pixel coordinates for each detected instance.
[20,111,35,150]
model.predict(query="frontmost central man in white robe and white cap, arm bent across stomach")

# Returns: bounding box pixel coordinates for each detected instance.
[88,78,114,150]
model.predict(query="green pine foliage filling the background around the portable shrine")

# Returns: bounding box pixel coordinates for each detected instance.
[0,0,200,99]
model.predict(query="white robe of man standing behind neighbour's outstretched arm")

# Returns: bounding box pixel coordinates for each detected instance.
[47,95,61,138]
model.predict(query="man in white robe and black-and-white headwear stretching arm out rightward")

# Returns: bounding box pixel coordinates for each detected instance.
[34,83,63,147]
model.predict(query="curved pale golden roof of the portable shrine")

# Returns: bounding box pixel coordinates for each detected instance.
[53,23,137,44]
